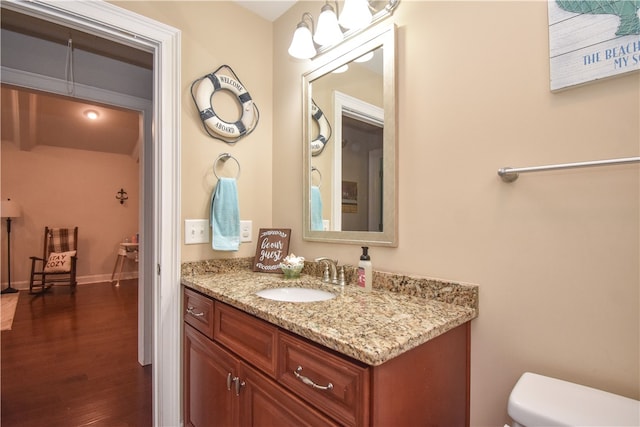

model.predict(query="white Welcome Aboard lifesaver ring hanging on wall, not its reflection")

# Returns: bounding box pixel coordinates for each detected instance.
[191,65,260,144]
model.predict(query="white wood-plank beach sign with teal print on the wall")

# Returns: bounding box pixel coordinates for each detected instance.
[548,0,640,91]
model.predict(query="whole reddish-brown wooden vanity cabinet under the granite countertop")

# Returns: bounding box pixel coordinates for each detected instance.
[184,289,470,427]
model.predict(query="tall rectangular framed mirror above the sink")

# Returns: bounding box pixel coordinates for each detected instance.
[302,24,398,246]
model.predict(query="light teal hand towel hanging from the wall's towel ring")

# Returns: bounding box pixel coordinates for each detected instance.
[209,178,240,251]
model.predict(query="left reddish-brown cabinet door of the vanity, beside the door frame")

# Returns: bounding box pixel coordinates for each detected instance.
[184,324,238,427]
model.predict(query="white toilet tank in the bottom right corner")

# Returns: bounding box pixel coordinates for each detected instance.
[508,372,640,427]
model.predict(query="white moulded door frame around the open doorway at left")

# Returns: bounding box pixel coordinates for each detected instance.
[2,0,182,426]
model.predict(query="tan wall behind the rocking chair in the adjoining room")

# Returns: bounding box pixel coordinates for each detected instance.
[1,141,139,288]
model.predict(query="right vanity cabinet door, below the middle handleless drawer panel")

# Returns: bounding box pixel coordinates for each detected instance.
[240,363,338,427]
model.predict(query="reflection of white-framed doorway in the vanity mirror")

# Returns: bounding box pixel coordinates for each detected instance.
[331,91,384,232]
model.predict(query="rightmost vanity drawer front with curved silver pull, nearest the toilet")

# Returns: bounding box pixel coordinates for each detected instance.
[277,333,370,425]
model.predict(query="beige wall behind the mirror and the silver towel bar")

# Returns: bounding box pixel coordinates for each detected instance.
[273,1,640,426]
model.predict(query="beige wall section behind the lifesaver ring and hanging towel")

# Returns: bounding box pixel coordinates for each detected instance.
[111,1,273,261]
